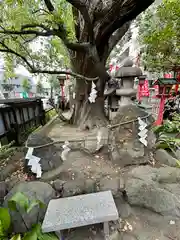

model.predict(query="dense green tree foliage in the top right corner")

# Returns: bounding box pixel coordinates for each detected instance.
[138,0,180,72]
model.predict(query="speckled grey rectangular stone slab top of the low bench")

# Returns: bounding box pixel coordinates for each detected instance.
[42,191,119,232]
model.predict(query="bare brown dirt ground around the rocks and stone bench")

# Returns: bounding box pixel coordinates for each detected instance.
[0,120,180,240]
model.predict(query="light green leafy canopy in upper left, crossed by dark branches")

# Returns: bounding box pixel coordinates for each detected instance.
[0,0,75,72]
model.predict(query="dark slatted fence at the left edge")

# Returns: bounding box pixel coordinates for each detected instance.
[0,98,45,144]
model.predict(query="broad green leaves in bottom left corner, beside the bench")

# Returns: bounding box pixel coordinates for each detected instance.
[0,192,58,240]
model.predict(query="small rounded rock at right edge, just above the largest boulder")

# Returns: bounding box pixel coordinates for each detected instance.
[154,149,177,167]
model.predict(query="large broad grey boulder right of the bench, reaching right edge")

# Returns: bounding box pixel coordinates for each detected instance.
[126,173,180,217]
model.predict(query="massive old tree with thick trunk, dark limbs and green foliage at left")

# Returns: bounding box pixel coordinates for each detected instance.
[0,0,154,129]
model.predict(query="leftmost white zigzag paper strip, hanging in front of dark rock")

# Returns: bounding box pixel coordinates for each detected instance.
[25,148,42,178]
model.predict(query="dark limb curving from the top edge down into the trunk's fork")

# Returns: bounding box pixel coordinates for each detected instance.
[67,0,95,44]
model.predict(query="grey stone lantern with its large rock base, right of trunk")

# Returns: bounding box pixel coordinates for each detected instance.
[109,59,155,167]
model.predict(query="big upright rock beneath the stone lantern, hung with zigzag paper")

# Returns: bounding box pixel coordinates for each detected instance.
[109,104,153,167]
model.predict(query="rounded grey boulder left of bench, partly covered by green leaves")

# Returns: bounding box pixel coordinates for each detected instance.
[4,181,55,233]
